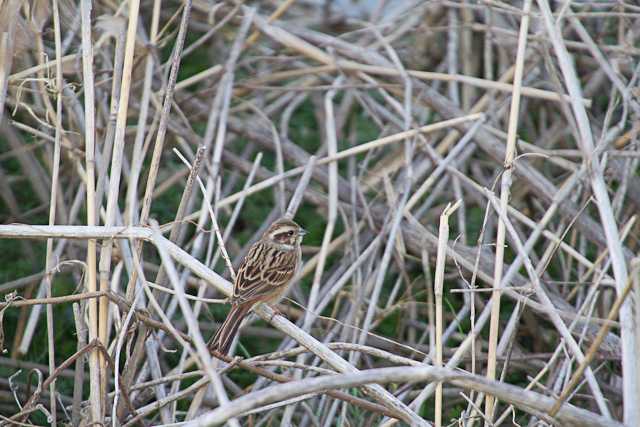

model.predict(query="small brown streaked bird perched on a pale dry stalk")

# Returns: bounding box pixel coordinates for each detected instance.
[209,217,307,355]
